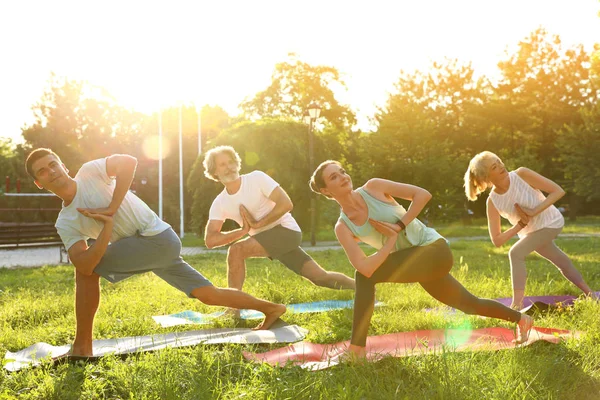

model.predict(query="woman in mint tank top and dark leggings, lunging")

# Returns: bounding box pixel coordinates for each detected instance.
[310,160,533,356]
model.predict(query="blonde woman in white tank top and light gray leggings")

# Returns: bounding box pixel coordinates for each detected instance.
[465,151,591,309]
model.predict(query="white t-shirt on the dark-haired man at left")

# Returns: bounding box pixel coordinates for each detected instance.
[55,158,171,250]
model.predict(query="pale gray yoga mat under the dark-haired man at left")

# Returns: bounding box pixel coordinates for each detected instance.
[4,320,308,371]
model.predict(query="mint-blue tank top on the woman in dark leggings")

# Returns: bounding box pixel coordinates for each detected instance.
[340,187,444,251]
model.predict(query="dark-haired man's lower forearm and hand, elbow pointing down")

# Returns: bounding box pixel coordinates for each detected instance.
[69,210,113,276]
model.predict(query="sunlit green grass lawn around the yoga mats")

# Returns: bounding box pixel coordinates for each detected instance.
[0,226,600,399]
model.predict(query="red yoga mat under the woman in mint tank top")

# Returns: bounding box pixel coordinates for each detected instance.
[244,327,578,371]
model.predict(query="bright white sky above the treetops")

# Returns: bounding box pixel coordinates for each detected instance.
[0,0,600,142]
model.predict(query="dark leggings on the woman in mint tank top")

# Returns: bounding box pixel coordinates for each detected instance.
[351,239,521,347]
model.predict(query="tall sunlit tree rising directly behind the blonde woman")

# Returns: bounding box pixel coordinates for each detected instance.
[496,28,593,180]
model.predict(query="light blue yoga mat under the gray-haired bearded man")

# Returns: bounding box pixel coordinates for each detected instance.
[152,300,383,327]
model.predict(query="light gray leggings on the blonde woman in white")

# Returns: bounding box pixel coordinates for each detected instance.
[508,228,583,292]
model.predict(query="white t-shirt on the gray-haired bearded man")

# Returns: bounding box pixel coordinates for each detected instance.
[208,171,300,236]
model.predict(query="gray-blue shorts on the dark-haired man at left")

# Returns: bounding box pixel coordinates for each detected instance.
[94,228,212,297]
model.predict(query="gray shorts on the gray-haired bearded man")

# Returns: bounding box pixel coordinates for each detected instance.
[252,225,312,275]
